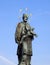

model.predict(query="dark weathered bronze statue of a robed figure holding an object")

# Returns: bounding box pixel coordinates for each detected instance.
[15,14,37,65]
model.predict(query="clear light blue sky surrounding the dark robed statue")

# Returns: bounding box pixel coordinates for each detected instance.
[0,0,50,65]
